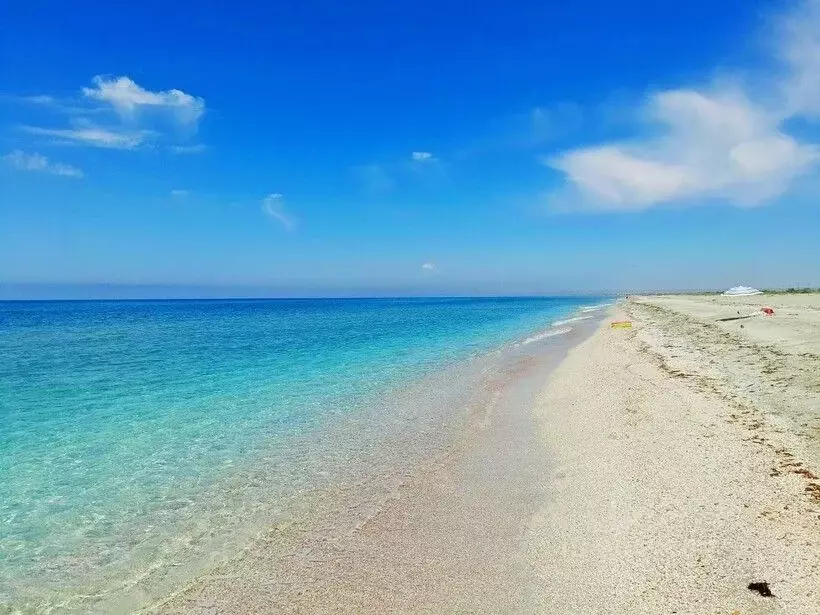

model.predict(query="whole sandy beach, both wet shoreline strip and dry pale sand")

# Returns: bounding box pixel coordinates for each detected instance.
[156,295,820,615]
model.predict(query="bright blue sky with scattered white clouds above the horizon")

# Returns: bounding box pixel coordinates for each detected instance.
[0,0,820,298]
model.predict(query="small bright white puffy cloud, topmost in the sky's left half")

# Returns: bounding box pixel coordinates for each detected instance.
[83,75,205,126]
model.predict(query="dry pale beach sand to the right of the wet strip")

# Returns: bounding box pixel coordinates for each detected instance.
[529,295,820,615]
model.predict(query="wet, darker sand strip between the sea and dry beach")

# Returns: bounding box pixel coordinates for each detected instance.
[152,311,603,613]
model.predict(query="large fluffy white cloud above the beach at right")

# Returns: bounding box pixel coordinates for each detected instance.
[545,0,820,210]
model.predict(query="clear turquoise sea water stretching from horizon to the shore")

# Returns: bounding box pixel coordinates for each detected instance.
[0,298,597,612]
